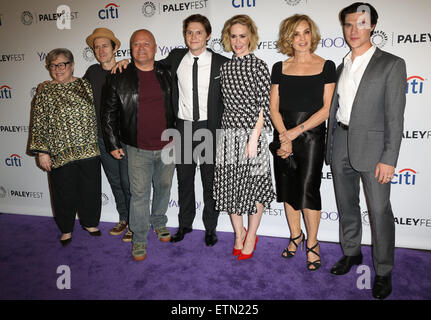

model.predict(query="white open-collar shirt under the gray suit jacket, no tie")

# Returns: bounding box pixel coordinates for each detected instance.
[337,46,376,125]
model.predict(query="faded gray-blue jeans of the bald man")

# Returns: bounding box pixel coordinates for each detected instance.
[127,145,175,243]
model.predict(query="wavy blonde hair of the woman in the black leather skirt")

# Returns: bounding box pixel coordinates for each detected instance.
[277,14,320,56]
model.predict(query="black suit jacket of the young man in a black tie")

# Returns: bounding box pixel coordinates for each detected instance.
[160,48,229,137]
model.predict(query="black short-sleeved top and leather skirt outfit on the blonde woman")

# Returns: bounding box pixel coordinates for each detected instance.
[271,60,336,210]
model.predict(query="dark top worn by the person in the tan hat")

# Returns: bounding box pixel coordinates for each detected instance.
[83,63,111,137]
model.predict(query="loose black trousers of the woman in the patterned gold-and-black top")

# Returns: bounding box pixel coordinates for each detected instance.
[49,157,102,233]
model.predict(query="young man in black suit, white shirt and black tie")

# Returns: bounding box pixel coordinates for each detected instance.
[161,14,229,246]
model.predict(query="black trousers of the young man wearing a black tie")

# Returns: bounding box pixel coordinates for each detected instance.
[176,119,219,231]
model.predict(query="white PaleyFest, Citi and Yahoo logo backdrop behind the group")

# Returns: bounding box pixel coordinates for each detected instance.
[0,0,431,249]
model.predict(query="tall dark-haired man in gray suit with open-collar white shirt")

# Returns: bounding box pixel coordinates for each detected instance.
[325,2,407,299]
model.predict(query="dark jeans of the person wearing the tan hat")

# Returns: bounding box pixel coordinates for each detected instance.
[98,137,130,222]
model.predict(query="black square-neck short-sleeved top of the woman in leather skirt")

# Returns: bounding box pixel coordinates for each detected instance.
[271,60,336,112]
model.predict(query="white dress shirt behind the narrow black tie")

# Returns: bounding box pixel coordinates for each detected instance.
[177,50,212,121]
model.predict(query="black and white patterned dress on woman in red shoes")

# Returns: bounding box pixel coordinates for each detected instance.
[213,53,275,215]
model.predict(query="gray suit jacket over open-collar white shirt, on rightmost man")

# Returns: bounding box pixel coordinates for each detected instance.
[325,48,407,171]
